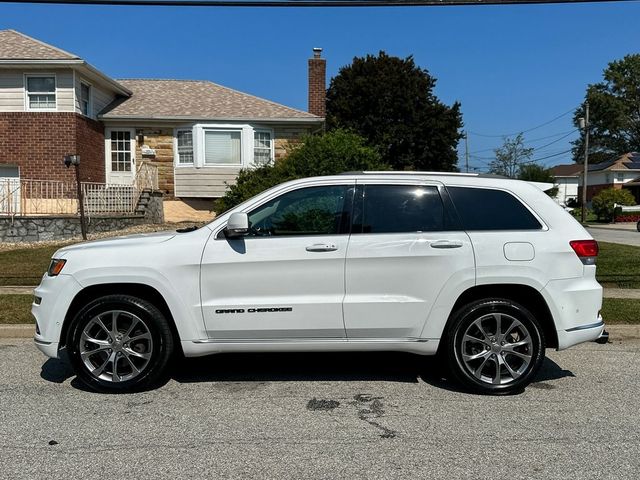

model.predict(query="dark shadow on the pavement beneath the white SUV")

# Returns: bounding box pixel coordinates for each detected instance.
[40,352,575,392]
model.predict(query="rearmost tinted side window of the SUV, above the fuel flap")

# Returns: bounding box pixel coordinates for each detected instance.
[447,187,542,230]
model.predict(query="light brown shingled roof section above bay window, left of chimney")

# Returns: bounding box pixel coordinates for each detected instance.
[101,79,320,120]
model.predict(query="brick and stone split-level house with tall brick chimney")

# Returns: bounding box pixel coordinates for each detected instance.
[0,30,325,198]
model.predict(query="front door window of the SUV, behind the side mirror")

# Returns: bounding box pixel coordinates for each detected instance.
[249,185,349,236]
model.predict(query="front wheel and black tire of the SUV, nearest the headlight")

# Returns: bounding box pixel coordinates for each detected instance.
[66,295,174,393]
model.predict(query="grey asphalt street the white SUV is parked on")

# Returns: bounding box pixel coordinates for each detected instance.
[0,339,640,480]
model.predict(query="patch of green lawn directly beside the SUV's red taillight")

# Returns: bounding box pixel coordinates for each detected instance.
[596,242,640,288]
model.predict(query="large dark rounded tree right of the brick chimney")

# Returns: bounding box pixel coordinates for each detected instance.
[327,51,462,171]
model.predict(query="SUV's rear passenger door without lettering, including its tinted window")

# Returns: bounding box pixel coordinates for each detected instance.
[343,180,475,339]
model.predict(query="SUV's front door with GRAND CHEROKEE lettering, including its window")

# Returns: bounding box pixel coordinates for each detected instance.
[201,180,354,340]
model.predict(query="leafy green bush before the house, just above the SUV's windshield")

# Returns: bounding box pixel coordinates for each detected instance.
[214,130,388,212]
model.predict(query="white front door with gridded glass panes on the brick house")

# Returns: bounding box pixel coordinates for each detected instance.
[105,129,136,185]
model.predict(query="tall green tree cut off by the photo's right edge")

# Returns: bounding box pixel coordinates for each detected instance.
[573,54,640,163]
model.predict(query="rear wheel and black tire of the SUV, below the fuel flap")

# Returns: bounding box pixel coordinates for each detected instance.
[443,298,545,395]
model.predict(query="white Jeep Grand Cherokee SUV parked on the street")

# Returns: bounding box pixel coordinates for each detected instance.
[32,172,604,393]
